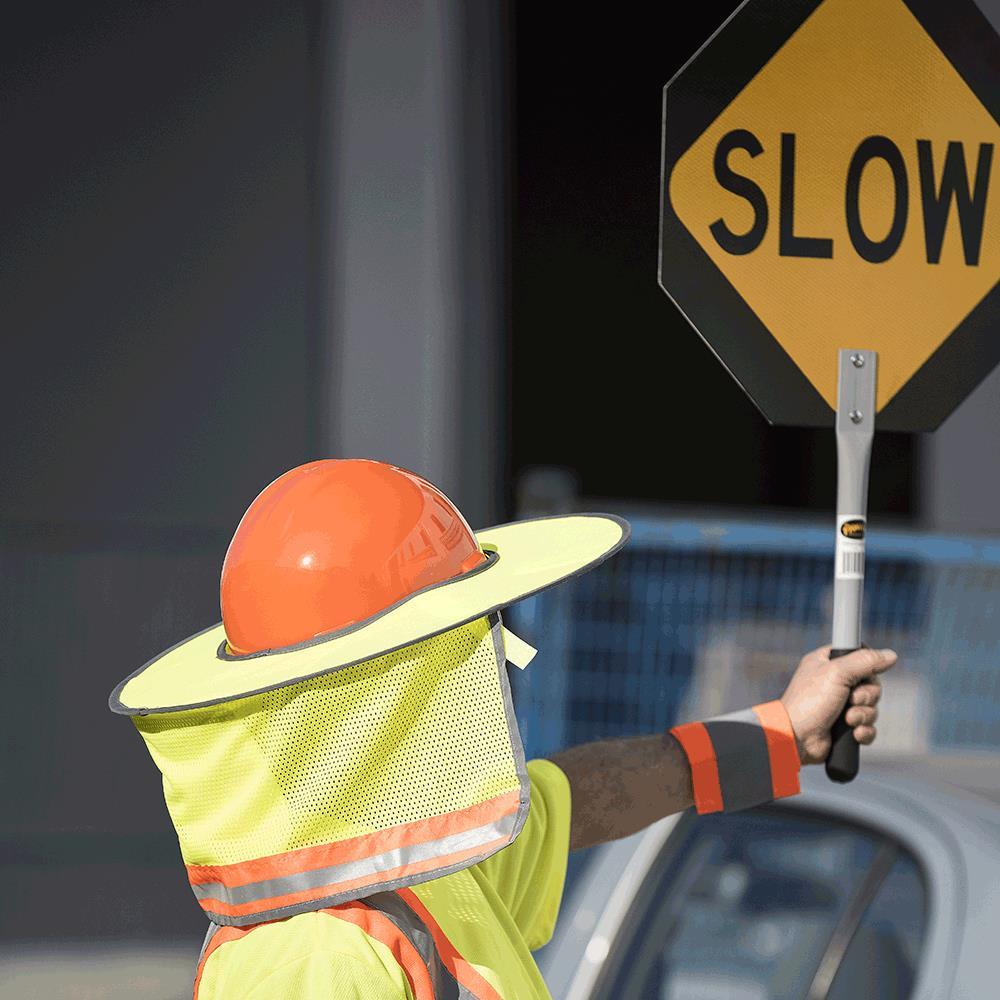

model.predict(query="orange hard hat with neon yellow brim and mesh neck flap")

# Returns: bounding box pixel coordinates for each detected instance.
[111,460,628,926]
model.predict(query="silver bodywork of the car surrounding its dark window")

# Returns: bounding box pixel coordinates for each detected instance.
[537,751,1000,1000]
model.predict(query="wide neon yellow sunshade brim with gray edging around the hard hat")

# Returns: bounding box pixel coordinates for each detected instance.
[109,514,629,715]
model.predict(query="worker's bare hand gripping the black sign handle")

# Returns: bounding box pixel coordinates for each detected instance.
[781,646,896,764]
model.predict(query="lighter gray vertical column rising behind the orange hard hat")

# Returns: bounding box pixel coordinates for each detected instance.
[318,0,507,526]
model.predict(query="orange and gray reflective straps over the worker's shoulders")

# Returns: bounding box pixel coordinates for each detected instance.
[194,889,502,1000]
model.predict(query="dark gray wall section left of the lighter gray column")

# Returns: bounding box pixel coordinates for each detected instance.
[0,0,318,938]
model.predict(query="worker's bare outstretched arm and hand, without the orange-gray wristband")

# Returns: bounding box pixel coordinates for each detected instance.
[551,646,896,851]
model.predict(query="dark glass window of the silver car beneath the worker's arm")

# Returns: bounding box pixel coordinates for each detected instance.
[600,808,923,1000]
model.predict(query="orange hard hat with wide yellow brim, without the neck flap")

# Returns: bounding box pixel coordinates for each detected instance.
[109,459,629,716]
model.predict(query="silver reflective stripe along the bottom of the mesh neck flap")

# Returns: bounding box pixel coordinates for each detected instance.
[191,813,518,920]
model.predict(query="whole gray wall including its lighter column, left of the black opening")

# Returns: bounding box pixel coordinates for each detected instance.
[0,0,506,941]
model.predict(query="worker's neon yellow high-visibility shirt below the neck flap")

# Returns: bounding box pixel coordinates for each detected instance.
[195,759,570,1000]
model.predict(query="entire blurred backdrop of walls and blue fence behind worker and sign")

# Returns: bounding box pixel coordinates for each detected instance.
[0,0,1000,1000]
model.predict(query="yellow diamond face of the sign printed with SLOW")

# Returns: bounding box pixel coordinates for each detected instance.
[661,0,1000,424]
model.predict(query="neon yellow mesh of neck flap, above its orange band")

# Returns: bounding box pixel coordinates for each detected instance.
[133,618,519,865]
